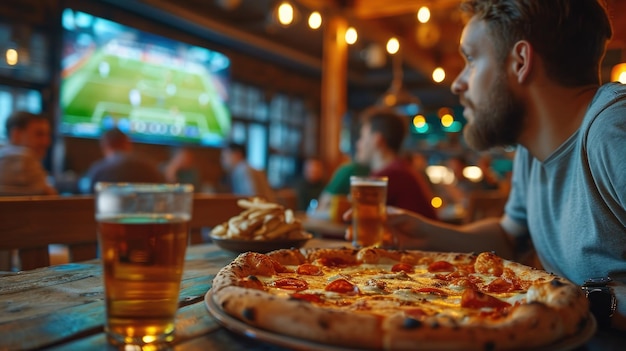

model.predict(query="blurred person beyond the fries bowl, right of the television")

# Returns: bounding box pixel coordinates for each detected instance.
[221,142,276,202]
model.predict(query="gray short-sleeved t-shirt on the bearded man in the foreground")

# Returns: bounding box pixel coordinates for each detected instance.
[503,83,626,312]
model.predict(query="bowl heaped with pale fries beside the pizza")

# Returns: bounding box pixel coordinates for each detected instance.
[210,198,313,253]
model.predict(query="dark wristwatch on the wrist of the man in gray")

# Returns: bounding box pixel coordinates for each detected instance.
[581,277,617,329]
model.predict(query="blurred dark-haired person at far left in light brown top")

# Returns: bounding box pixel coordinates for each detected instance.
[0,111,57,196]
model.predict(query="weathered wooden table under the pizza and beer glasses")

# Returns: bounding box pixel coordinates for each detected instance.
[0,239,626,351]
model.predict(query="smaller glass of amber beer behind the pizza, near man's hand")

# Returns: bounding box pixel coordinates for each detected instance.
[350,176,387,248]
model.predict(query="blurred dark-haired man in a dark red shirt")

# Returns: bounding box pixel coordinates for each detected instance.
[355,107,437,219]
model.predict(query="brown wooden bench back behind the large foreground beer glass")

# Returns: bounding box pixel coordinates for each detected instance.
[0,194,242,271]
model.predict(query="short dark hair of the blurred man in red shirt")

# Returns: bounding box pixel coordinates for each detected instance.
[361,106,409,153]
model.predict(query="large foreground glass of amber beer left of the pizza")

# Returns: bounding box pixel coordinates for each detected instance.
[95,183,193,346]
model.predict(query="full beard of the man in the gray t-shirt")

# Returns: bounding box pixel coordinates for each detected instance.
[463,75,526,151]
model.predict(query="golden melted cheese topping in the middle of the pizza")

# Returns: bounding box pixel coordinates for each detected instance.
[258,262,525,321]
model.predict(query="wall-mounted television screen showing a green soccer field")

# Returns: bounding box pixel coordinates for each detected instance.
[60,9,231,146]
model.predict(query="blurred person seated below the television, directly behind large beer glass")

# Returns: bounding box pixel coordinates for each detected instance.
[79,128,166,193]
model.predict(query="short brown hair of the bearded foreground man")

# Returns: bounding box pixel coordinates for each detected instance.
[461,0,613,86]
